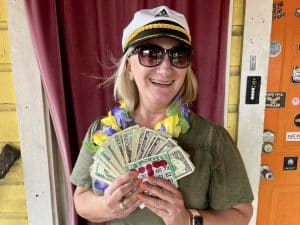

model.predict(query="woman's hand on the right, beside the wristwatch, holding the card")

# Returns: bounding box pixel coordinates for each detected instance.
[138,177,190,225]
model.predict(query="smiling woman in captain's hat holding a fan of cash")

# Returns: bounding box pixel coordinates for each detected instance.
[71,6,253,225]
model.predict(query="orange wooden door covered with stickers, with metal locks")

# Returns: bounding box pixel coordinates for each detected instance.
[257,0,300,225]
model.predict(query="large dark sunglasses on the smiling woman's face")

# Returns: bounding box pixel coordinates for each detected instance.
[128,44,192,68]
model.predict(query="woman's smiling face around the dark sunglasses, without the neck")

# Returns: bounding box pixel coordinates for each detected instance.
[127,38,188,109]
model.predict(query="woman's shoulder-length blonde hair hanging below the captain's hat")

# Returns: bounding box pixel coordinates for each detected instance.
[104,47,198,116]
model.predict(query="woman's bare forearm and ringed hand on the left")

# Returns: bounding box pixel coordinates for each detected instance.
[74,172,141,222]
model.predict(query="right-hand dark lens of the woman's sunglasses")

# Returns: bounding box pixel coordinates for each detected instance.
[169,46,192,68]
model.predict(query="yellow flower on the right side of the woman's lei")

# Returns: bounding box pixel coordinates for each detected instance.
[154,114,181,138]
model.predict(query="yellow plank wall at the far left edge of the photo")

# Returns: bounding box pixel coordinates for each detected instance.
[0,0,28,225]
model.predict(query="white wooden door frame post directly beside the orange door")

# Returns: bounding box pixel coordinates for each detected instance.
[237,0,273,225]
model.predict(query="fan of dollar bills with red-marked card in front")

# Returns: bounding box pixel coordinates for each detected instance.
[90,125,195,187]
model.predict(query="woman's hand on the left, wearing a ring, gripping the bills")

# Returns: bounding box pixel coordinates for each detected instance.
[104,171,143,219]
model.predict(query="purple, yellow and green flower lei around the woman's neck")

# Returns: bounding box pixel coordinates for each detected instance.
[86,98,190,152]
